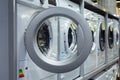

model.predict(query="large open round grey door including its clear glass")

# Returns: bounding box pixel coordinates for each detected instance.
[25,7,92,73]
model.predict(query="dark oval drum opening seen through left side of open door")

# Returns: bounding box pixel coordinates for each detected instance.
[37,23,50,55]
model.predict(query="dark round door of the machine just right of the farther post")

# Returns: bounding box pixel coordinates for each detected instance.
[108,26,114,49]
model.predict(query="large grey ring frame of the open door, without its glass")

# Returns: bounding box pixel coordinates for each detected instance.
[25,7,92,73]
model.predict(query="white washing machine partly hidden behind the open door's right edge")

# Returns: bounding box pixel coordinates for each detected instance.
[84,9,98,74]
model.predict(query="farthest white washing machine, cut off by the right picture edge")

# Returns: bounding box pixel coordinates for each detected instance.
[113,19,119,58]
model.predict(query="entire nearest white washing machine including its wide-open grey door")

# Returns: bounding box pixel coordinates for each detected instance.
[16,0,92,80]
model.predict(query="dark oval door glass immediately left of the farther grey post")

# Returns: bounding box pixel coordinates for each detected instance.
[99,23,105,51]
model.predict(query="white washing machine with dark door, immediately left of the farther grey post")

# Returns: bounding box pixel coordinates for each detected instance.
[96,14,106,67]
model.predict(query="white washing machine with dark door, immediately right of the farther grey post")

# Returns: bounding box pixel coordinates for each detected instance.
[107,18,114,61]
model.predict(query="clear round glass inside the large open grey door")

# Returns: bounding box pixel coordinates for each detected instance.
[36,16,78,61]
